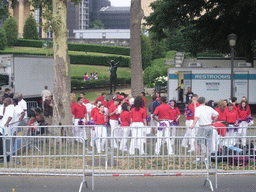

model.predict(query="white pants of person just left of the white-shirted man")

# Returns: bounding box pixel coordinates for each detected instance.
[181,119,198,150]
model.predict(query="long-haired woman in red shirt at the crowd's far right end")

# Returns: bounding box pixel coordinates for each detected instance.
[237,100,251,146]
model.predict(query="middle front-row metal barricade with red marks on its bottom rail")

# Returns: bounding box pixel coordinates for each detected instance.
[92,127,215,190]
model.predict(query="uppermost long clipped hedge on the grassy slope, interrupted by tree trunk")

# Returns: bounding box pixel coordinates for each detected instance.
[14,39,130,56]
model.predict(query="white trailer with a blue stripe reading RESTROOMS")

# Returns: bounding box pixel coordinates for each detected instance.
[168,58,256,108]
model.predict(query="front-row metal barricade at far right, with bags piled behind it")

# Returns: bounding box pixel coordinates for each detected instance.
[212,127,256,188]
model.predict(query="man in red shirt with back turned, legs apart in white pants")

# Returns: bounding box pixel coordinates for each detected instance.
[153,97,173,155]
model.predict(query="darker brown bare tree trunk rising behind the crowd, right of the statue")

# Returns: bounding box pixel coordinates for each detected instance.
[130,0,144,97]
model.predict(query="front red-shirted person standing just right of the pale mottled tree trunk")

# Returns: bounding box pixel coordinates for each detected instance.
[72,97,87,142]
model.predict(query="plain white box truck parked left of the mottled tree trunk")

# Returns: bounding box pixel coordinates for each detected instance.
[0,55,54,100]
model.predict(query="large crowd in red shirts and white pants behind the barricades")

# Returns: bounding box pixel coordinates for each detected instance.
[68,89,252,155]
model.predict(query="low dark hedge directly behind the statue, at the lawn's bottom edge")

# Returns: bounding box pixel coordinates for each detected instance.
[71,78,131,90]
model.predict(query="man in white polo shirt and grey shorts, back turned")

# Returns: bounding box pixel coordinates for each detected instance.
[190,97,219,162]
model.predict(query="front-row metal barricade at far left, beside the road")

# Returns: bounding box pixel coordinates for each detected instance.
[0,136,88,191]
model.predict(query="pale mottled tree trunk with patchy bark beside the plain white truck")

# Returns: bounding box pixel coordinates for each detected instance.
[53,0,72,125]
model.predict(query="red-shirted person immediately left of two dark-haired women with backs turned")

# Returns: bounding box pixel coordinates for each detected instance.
[109,99,121,148]
